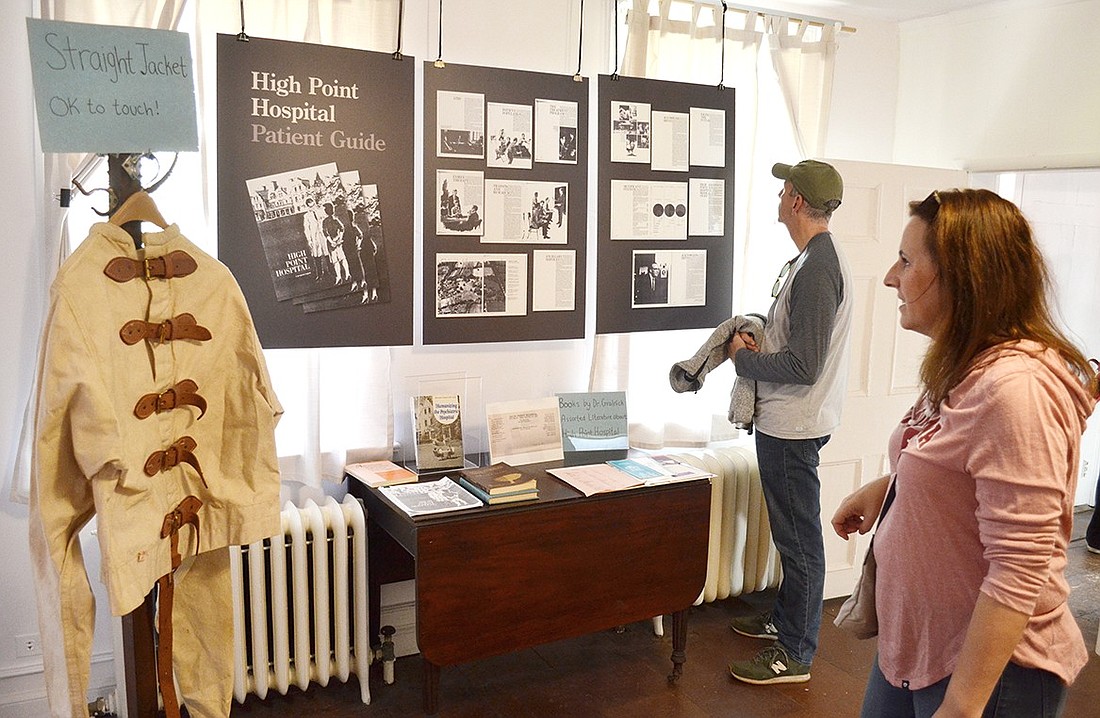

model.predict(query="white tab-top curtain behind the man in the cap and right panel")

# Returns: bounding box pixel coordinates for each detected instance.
[591,0,837,448]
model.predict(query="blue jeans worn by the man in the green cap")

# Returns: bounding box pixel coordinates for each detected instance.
[756,430,829,664]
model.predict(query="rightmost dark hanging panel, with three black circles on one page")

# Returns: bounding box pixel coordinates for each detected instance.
[596,76,735,334]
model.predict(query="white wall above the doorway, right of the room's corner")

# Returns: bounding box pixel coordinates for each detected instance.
[894,0,1100,170]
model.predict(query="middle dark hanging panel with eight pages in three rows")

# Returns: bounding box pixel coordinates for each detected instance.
[424,63,589,344]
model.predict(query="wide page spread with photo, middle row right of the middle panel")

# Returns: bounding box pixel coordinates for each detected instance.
[482,179,569,244]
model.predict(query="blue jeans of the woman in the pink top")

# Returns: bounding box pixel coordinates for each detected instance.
[859,655,1066,718]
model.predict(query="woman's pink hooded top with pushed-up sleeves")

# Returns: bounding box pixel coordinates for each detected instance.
[875,342,1096,691]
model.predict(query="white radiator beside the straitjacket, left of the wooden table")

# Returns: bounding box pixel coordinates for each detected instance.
[230,495,371,704]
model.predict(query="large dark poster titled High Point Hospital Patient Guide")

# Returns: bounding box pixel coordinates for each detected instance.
[218,35,413,349]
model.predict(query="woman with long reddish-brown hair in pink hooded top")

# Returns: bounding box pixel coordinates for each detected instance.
[833,189,1097,718]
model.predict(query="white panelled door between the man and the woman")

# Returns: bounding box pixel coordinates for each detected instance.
[818,159,967,598]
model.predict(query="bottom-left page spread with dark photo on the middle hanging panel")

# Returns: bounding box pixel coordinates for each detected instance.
[436,254,527,317]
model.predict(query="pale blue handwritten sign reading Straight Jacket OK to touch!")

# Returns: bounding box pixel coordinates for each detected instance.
[26,18,199,154]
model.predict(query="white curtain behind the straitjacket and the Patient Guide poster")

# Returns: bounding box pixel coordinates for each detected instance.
[11,0,398,502]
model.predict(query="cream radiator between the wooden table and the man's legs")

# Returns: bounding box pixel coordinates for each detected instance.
[675,446,781,605]
